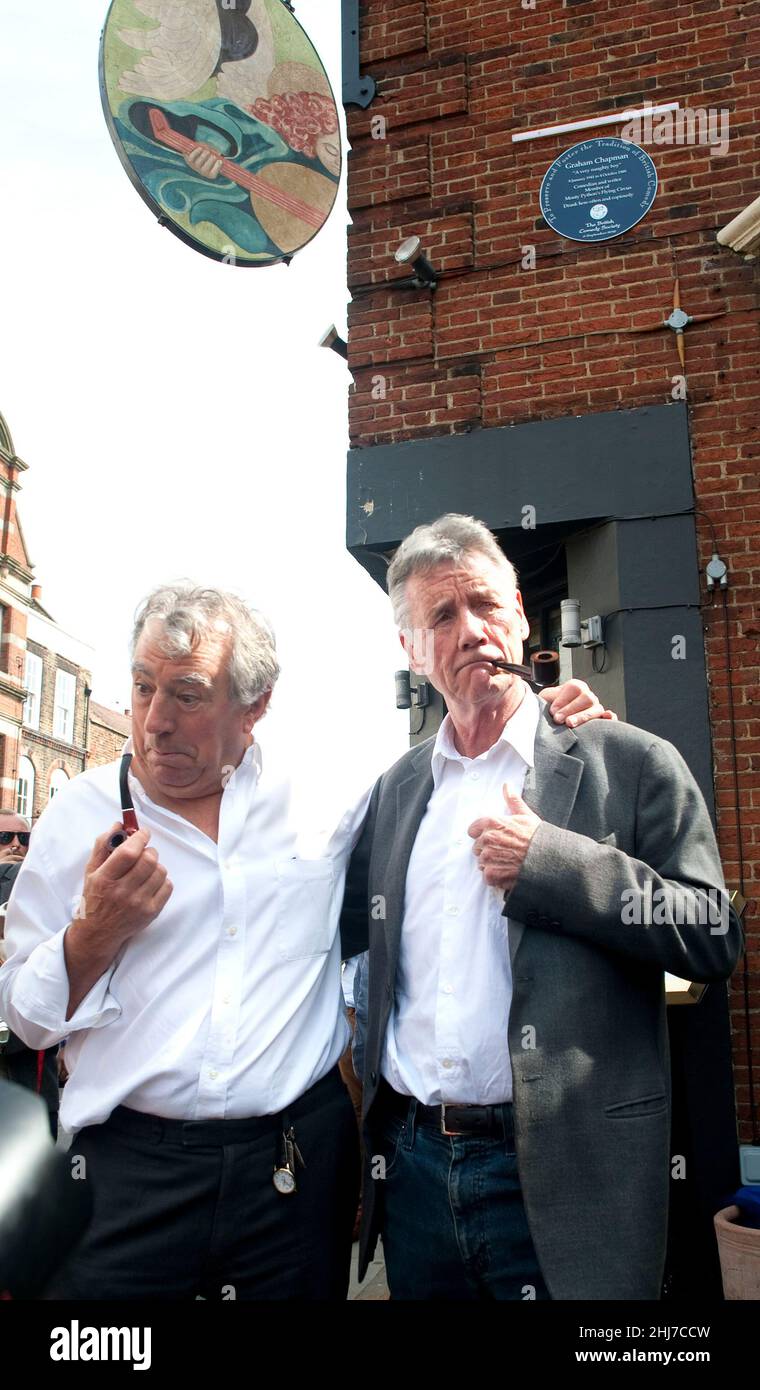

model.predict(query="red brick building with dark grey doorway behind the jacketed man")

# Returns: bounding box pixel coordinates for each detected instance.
[343,0,760,1295]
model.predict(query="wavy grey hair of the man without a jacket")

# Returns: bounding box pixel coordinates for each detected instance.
[131,580,279,706]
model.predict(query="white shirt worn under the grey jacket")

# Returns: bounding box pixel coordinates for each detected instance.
[382,688,540,1105]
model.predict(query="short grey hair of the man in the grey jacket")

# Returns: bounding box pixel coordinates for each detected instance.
[386,512,517,628]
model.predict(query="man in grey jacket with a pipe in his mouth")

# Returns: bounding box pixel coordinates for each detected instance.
[342,516,742,1300]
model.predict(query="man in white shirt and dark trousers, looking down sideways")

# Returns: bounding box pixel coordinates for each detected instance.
[0,584,358,1300]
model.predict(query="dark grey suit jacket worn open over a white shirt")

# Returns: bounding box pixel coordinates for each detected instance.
[342,710,742,1300]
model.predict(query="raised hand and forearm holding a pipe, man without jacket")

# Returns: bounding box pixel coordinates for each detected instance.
[64,823,172,1019]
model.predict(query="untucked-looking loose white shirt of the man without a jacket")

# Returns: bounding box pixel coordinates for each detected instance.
[0,744,357,1130]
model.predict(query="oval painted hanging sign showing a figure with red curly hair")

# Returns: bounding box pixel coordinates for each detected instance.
[100,0,342,265]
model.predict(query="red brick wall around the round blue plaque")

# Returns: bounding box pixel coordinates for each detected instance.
[349,0,760,1137]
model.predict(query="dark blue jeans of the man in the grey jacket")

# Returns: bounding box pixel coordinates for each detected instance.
[374,1101,550,1300]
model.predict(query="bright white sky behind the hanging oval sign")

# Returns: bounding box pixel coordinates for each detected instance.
[0,0,407,812]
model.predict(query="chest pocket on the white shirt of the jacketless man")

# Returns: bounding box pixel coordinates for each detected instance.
[276,859,335,960]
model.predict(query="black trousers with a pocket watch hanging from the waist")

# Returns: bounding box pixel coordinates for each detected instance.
[44,1068,358,1301]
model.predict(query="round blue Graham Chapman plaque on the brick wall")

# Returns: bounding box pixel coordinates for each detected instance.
[540,139,657,242]
